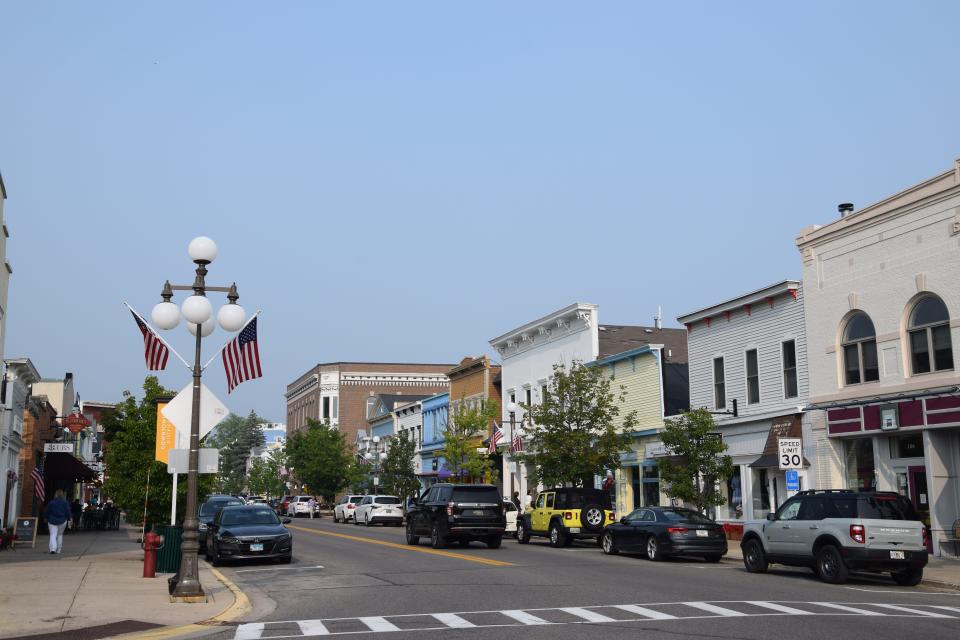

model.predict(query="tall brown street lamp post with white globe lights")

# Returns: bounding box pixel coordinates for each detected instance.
[151,236,246,602]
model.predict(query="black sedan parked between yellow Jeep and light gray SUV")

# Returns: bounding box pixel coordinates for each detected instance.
[600,507,727,562]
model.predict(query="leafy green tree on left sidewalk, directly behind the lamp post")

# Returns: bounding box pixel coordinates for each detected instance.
[102,376,214,524]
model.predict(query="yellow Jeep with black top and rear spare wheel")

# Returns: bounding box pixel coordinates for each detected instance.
[517,487,616,547]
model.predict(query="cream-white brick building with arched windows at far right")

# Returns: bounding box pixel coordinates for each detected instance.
[797,161,960,555]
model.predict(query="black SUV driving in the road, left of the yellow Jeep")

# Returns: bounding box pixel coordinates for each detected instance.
[407,484,507,549]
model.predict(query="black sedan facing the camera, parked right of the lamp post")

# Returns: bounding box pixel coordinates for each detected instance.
[206,504,293,566]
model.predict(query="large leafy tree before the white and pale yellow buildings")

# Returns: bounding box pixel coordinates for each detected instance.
[517,361,637,487]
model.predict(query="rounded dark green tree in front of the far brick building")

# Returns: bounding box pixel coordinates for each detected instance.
[287,418,358,502]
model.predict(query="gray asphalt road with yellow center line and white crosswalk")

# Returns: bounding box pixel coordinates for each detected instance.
[208,518,960,640]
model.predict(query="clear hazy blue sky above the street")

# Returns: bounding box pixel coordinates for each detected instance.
[0,0,960,421]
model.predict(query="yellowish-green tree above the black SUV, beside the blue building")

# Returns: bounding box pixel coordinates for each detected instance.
[442,401,500,482]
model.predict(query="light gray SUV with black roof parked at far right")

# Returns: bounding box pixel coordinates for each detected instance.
[740,490,927,586]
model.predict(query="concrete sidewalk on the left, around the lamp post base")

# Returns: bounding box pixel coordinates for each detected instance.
[0,527,246,640]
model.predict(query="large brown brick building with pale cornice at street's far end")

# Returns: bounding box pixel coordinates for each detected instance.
[286,362,453,442]
